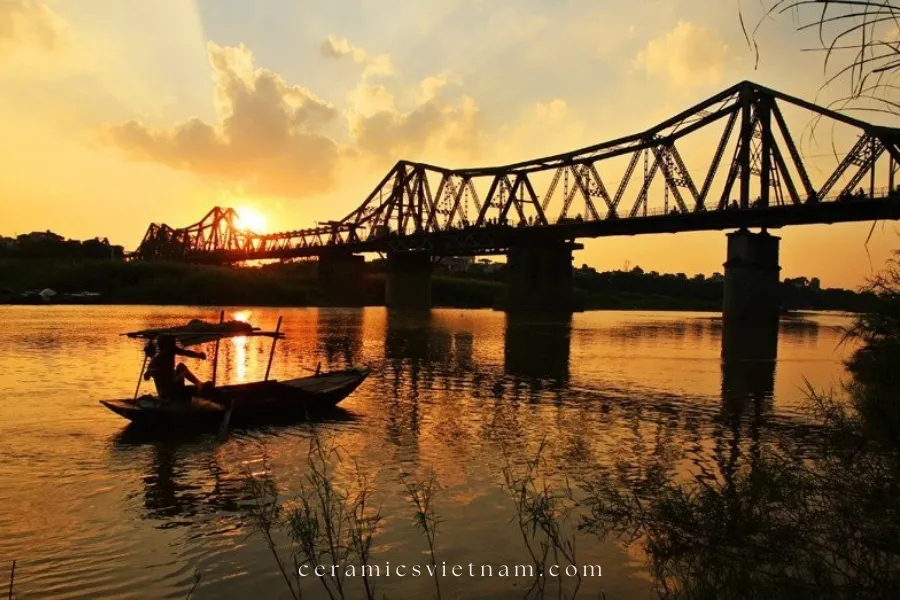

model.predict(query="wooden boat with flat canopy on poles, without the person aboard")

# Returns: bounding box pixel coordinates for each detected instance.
[100,315,369,431]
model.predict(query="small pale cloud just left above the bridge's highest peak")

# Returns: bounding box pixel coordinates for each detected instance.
[634,21,729,87]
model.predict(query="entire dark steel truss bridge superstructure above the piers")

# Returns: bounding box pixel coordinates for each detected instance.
[131,82,900,263]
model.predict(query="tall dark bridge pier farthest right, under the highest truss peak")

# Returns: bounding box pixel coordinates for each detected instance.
[722,229,781,329]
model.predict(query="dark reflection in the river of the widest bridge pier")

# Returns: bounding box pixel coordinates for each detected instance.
[503,313,572,384]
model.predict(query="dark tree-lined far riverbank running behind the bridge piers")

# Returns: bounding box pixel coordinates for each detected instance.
[0,258,878,313]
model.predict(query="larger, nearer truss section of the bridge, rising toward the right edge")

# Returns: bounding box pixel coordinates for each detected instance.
[343,82,900,235]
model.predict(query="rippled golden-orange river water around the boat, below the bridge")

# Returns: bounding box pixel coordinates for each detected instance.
[0,306,851,599]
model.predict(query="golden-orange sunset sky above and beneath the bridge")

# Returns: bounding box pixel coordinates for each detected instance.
[0,0,898,286]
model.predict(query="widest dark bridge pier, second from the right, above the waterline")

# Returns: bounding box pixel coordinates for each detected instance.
[500,241,584,314]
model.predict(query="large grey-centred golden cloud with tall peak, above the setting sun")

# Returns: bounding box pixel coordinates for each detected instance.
[107,43,340,196]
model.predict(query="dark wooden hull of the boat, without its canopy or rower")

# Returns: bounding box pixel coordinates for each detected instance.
[100,369,369,431]
